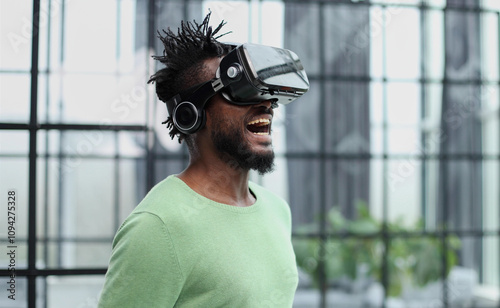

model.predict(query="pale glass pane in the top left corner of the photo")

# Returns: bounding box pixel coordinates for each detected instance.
[0,0,33,70]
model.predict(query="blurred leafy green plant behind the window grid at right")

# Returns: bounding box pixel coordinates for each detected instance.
[293,202,460,296]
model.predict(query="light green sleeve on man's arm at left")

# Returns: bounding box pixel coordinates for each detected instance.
[98,212,183,308]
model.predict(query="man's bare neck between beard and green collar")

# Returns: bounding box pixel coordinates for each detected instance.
[178,150,255,207]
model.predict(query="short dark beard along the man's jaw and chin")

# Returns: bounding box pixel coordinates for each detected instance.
[211,122,274,175]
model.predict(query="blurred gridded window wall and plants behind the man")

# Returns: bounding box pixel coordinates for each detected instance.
[0,0,500,308]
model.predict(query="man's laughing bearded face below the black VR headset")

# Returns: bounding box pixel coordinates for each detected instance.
[201,59,274,174]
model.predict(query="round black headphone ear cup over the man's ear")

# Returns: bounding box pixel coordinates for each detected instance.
[172,102,205,135]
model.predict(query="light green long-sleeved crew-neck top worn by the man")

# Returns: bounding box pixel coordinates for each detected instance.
[99,176,298,308]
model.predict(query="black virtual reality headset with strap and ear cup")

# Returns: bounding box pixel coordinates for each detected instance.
[166,44,309,134]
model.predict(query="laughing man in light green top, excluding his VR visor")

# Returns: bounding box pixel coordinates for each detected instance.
[99,14,308,307]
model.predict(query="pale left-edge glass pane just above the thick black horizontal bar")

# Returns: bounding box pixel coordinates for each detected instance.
[0,73,31,123]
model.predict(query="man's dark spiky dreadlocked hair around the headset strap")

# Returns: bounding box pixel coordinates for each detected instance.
[148,12,230,143]
